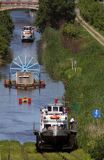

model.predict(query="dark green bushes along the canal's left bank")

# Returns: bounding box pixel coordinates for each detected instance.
[0,11,13,65]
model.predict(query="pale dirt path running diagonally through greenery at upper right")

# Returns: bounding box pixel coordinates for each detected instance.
[75,8,104,46]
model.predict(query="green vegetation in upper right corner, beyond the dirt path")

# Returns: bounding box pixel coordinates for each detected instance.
[79,0,104,32]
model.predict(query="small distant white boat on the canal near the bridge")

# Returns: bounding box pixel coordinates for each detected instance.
[21,26,35,42]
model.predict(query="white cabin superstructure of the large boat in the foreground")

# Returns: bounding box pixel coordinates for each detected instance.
[40,102,68,130]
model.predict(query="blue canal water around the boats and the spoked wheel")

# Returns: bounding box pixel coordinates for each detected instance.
[0,11,64,143]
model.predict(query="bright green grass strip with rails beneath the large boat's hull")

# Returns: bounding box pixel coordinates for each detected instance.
[0,141,91,160]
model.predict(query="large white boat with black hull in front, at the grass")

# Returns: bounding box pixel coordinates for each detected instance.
[33,100,77,150]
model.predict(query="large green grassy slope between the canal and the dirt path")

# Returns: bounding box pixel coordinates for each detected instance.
[42,27,104,151]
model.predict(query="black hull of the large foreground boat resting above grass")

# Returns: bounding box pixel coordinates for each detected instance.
[33,130,76,150]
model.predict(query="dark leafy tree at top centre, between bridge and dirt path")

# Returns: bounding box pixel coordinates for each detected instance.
[36,0,75,31]
